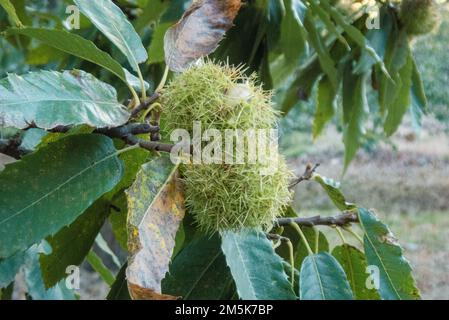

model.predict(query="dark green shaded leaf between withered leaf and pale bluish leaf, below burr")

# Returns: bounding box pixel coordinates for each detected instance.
[162,235,234,300]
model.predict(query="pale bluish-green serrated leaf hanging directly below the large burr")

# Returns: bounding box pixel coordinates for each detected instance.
[221,230,296,300]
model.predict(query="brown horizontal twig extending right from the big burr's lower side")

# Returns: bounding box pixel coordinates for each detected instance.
[276,212,359,227]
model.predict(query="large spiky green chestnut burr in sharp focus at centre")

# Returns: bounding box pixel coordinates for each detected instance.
[161,61,292,233]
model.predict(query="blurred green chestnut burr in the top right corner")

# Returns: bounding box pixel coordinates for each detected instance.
[399,0,439,36]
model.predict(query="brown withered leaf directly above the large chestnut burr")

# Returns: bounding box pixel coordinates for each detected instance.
[164,0,241,72]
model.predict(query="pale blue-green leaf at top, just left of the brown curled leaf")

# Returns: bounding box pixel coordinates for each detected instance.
[74,0,148,73]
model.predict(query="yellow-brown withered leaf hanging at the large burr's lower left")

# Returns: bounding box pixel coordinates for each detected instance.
[126,156,185,300]
